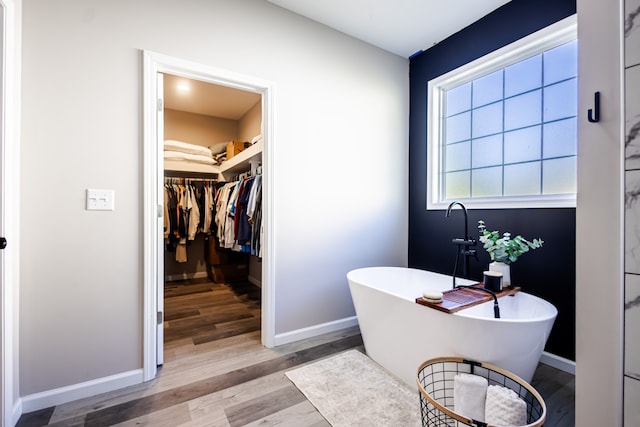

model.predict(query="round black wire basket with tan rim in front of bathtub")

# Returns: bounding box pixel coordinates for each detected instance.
[417,357,547,427]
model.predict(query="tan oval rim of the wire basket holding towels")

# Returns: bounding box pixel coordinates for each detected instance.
[416,356,547,427]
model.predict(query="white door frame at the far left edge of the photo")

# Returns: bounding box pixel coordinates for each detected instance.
[0,0,22,426]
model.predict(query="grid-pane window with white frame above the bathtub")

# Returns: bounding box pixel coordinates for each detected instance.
[429,15,578,208]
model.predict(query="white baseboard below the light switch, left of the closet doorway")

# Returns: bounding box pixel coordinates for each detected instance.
[18,369,143,418]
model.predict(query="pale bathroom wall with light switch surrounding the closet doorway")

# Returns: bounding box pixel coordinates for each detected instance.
[19,0,409,402]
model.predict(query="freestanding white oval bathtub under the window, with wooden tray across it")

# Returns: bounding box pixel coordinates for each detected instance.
[347,267,558,387]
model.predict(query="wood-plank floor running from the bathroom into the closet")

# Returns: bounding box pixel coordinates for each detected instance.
[17,279,575,427]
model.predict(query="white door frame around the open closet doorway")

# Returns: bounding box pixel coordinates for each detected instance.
[143,51,275,381]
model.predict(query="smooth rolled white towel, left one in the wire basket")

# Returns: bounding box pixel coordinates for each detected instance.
[453,373,488,421]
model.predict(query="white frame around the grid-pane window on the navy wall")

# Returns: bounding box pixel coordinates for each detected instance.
[427,15,577,210]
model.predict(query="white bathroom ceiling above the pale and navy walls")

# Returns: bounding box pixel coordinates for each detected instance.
[267,0,509,58]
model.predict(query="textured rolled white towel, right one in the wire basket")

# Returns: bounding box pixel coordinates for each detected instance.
[485,385,527,426]
